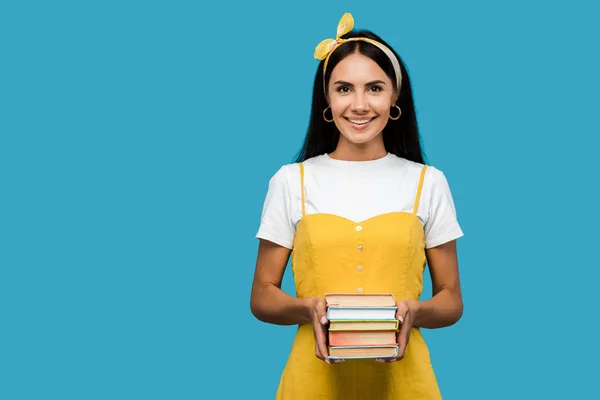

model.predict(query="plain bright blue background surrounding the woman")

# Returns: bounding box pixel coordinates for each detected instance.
[0,1,600,400]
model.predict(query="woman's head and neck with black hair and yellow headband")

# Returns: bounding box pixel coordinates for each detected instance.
[297,14,423,163]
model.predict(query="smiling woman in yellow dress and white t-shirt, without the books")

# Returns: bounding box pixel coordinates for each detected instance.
[251,14,463,400]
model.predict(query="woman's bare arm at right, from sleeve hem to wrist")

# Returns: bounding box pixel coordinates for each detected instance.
[409,240,463,328]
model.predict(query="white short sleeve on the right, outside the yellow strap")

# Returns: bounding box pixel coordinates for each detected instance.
[424,167,464,249]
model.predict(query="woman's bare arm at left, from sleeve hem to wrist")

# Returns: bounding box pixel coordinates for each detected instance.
[250,240,315,325]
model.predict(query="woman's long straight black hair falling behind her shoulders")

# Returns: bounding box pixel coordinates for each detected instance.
[296,30,424,164]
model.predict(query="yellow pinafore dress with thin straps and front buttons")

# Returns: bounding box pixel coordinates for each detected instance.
[276,163,442,400]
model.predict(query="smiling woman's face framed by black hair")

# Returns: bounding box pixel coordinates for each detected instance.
[325,53,396,144]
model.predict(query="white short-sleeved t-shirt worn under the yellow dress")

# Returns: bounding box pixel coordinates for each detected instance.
[256,153,463,249]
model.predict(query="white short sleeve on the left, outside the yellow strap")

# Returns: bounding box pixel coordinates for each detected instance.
[256,166,295,249]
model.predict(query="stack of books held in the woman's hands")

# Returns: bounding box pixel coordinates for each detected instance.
[325,293,398,359]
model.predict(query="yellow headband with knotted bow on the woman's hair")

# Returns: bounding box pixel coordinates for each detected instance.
[315,13,402,92]
